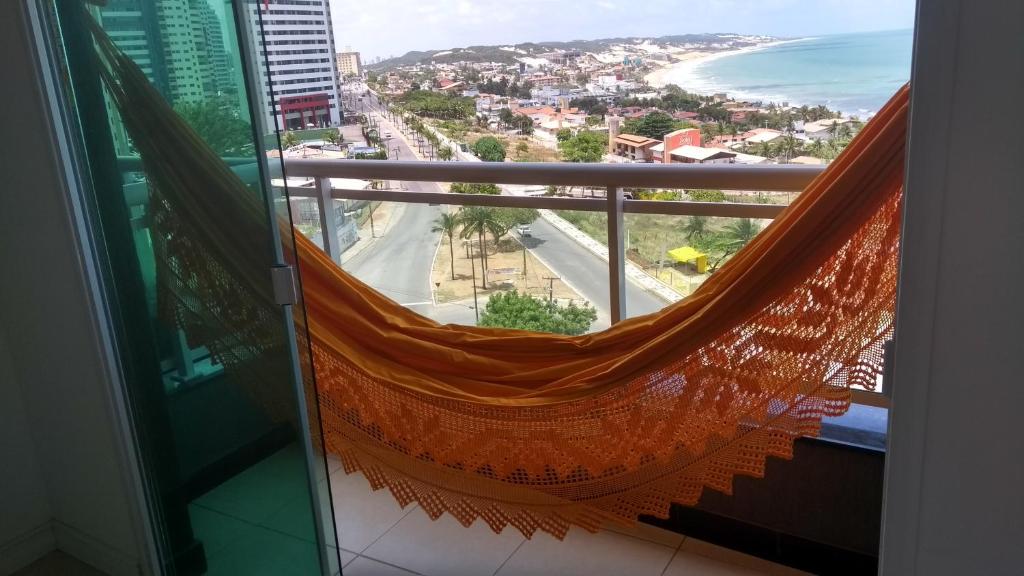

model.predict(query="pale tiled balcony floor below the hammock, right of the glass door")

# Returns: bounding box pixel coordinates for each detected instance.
[330,460,806,576]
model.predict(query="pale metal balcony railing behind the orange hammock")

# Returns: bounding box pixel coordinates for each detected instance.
[116,152,888,406]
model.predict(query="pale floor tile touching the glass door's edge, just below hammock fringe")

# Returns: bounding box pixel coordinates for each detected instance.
[331,463,415,552]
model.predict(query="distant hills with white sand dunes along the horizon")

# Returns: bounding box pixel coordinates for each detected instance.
[368,34,776,71]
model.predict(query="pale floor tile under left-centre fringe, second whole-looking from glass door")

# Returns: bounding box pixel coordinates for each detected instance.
[362,508,524,576]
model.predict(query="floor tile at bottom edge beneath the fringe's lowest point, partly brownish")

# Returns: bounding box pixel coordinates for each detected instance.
[498,529,675,576]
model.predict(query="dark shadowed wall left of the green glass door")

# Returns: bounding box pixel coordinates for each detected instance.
[0,1,144,574]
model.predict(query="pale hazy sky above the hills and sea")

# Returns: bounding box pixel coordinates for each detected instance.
[331,0,914,61]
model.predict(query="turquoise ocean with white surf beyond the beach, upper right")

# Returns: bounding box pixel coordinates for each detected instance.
[664,30,913,118]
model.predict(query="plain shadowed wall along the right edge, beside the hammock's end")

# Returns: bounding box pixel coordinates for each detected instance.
[882,0,1024,576]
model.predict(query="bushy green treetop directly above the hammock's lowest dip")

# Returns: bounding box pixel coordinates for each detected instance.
[479,290,597,336]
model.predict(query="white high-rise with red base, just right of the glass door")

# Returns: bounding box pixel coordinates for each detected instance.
[250,0,341,133]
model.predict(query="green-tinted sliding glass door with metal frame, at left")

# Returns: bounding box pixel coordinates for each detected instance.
[38,0,339,575]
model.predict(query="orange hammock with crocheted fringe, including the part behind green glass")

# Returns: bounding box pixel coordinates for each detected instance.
[86,13,907,538]
